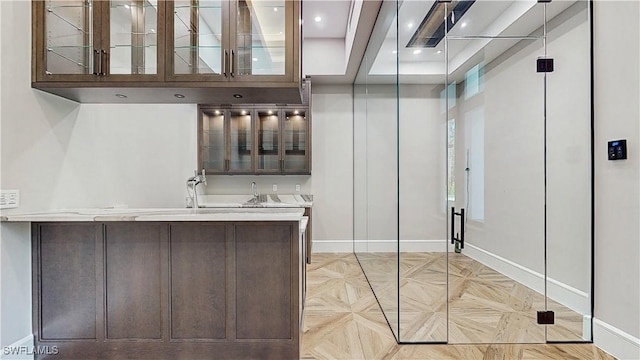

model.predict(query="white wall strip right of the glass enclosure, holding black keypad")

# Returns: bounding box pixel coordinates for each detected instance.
[594,1,640,359]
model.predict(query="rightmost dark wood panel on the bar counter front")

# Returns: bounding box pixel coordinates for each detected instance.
[234,223,298,339]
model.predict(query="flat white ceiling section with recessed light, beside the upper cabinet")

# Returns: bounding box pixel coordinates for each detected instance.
[302,0,355,39]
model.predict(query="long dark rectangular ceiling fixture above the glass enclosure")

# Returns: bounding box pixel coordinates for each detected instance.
[407,0,475,48]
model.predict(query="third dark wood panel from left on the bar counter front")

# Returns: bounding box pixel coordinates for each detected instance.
[169,223,229,339]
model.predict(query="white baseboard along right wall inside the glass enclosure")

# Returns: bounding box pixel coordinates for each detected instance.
[462,244,591,316]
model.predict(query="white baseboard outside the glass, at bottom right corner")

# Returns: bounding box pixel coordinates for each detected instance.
[593,318,640,360]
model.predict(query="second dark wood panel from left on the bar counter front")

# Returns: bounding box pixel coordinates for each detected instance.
[105,222,167,339]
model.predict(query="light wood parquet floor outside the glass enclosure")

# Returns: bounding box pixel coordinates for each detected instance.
[300,254,614,360]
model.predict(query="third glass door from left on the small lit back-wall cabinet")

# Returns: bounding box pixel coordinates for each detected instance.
[256,109,282,172]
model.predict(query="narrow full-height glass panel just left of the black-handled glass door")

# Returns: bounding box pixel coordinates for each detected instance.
[398,1,448,342]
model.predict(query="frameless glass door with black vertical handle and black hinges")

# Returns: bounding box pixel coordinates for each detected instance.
[446,35,545,343]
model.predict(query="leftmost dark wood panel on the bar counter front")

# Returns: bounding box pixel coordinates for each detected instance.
[34,224,101,340]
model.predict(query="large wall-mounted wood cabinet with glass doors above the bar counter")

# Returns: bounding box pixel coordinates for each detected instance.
[32,0,302,104]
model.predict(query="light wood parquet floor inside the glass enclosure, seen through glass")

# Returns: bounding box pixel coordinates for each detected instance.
[358,252,583,343]
